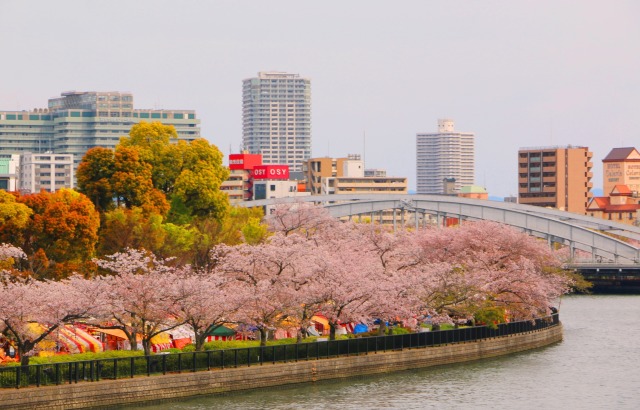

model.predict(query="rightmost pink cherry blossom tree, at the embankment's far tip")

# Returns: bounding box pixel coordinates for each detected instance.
[414,221,571,319]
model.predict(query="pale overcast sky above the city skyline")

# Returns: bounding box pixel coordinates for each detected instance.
[0,0,640,196]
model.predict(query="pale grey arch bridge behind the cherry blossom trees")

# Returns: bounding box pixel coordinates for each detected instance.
[239,194,640,269]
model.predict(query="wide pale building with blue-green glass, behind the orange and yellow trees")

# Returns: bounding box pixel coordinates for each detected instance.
[0,91,200,168]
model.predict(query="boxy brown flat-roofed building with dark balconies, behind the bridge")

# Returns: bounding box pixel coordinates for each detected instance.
[518,145,593,215]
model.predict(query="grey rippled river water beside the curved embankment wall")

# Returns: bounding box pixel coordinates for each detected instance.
[136,295,640,410]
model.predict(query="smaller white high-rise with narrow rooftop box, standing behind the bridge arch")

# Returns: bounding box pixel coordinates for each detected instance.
[416,119,475,194]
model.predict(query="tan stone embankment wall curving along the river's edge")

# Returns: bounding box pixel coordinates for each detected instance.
[0,325,562,409]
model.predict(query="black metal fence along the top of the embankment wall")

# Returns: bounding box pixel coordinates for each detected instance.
[0,314,560,388]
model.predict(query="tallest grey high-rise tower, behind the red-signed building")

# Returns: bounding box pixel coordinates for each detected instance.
[242,72,311,172]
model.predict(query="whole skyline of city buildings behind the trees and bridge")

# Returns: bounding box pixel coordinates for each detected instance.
[0,72,640,225]
